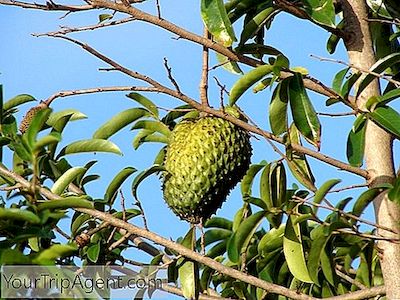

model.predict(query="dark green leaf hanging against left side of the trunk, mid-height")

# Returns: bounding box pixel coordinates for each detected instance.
[346,115,367,167]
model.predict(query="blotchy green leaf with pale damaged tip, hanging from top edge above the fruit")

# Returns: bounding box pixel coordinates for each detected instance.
[201,0,236,47]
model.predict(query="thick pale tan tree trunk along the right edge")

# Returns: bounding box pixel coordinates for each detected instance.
[341,0,400,299]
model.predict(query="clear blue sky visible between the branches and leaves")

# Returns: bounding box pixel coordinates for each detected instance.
[0,0,390,298]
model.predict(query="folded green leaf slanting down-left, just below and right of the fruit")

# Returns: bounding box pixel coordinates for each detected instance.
[228,211,265,263]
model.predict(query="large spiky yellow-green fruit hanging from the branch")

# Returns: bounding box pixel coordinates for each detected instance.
[163,116,252,224]
